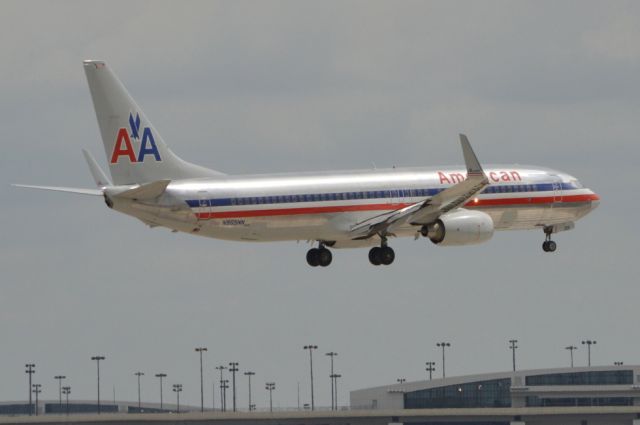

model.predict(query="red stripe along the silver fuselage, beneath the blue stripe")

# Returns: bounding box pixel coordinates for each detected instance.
[196,194,600,219]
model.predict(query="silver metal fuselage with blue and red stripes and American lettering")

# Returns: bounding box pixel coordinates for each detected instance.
[105,165,599,248]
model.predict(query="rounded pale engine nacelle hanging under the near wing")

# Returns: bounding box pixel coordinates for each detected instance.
[422,209,493,246]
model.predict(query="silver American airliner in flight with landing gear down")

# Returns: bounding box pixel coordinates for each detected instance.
[15,60,600,267]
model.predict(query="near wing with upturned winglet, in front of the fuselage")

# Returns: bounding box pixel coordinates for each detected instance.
[350,134,489,239]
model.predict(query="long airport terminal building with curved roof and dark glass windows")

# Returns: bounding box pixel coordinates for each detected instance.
[351,365,640,409]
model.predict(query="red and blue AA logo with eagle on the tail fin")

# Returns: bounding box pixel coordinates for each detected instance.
[111,113,162,164]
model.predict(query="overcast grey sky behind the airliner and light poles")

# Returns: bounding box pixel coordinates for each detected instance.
[0,0,640,406]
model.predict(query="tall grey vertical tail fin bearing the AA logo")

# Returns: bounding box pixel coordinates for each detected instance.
[84,60,223,185]
